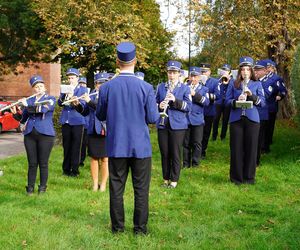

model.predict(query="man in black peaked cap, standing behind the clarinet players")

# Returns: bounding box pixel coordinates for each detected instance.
[200,63,220,159]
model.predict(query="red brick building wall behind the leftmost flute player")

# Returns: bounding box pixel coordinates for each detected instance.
[0,63,61,100]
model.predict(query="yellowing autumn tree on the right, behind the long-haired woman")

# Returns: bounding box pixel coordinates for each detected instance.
[193,0,300,117]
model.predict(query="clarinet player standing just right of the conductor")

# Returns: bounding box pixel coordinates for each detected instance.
[156,61,192,188]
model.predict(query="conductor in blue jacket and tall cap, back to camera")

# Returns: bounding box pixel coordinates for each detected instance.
[97,42,159,234]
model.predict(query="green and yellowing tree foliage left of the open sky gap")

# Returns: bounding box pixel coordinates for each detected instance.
[0,0,171,83]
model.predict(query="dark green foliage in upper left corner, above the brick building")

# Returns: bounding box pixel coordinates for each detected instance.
[0,0,53,75]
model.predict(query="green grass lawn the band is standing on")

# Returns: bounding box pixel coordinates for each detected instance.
[0,122,300,249]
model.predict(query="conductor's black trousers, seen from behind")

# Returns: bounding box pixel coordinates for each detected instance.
[108,157,151,233]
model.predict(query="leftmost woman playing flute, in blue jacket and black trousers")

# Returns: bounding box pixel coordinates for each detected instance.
[11,75,56,195]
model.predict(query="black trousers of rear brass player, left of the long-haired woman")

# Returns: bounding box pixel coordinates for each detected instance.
[212,104,231,140]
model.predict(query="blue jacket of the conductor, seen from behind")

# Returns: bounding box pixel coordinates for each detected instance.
[96,72,159,158]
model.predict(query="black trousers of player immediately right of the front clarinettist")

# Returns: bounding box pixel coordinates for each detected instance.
[183,125,204,167]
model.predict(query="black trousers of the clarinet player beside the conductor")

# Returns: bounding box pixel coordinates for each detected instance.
[157,128,186,182]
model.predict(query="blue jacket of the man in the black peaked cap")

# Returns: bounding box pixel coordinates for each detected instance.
[204,77,220,116]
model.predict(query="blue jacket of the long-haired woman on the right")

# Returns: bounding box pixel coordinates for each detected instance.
[225,80,265,123]
